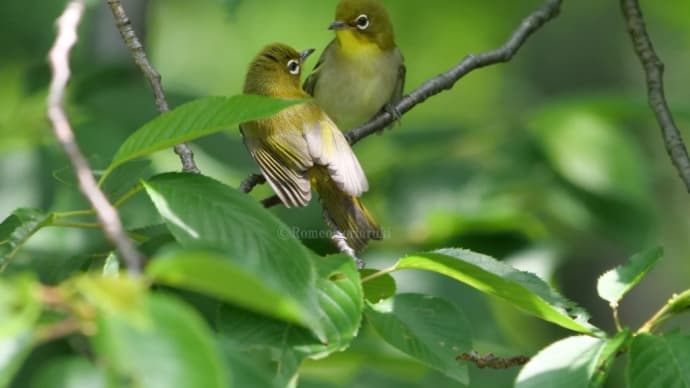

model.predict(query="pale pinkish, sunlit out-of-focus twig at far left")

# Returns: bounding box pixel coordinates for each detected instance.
[48,0,142,273]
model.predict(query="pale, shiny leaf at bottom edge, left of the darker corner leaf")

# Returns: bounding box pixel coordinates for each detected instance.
[515,335,607,388]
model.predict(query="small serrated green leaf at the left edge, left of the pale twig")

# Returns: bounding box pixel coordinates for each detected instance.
[0,208,53,272]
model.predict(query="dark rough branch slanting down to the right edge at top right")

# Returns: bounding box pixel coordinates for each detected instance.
[621,0,690,192]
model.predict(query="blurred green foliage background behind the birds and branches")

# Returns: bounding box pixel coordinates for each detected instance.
[0,0,690,387]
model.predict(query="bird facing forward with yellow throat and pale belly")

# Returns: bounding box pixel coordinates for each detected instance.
[304,0,405,130]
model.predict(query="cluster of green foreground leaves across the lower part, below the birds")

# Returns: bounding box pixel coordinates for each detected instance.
[0,96,690,387]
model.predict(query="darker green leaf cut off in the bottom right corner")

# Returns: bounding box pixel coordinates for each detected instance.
[627,332,690,388]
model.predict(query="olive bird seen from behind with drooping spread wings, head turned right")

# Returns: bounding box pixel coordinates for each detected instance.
[240,44,381,268]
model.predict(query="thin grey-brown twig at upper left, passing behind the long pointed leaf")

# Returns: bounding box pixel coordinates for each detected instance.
[107,0,200,174]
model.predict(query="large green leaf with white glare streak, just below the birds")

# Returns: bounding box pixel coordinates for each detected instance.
[144,173,324,337]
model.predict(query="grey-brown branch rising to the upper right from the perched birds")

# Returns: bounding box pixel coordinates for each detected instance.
[250,0,562,205]
